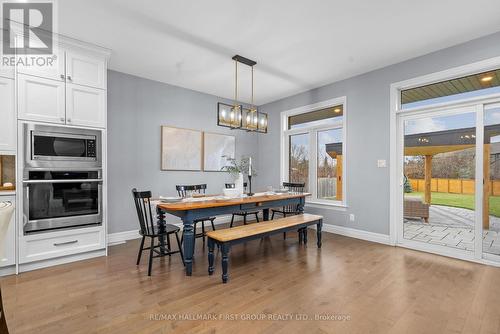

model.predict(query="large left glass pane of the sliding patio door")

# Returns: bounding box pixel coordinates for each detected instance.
[400,107,476,255]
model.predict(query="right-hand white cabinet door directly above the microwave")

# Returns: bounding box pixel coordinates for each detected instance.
[66,83,106,128]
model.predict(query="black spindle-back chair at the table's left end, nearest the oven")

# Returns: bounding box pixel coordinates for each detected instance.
[132,188,184,276]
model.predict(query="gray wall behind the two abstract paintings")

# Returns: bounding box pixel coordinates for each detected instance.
[108,71,258,233]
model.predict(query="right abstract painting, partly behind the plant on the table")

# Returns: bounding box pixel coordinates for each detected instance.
[203,132,236,172]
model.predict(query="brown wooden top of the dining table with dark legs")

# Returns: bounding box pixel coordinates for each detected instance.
[158,193,311,211]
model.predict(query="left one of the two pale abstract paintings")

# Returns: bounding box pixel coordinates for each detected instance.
[161,126,203,171]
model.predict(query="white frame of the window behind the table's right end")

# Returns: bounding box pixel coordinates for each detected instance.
[280,96,347,208]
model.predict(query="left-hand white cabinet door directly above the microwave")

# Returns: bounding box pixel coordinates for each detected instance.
[17,74,65,124]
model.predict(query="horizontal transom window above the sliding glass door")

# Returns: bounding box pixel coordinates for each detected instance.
[401,69,500,109]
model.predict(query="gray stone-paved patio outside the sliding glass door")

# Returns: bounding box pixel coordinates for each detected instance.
[404,205,500,255]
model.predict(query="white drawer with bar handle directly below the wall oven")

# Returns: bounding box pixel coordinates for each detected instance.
[19,227,104,263]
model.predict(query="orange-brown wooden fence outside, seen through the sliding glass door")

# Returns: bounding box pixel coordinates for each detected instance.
[410,179,500,196]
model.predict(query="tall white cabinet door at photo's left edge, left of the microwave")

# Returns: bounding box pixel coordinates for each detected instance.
[0,77,16,152]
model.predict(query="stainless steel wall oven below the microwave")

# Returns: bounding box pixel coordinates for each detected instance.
[23,170,102,234]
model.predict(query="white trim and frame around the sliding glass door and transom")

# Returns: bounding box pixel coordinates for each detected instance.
[389,57,500,265]
